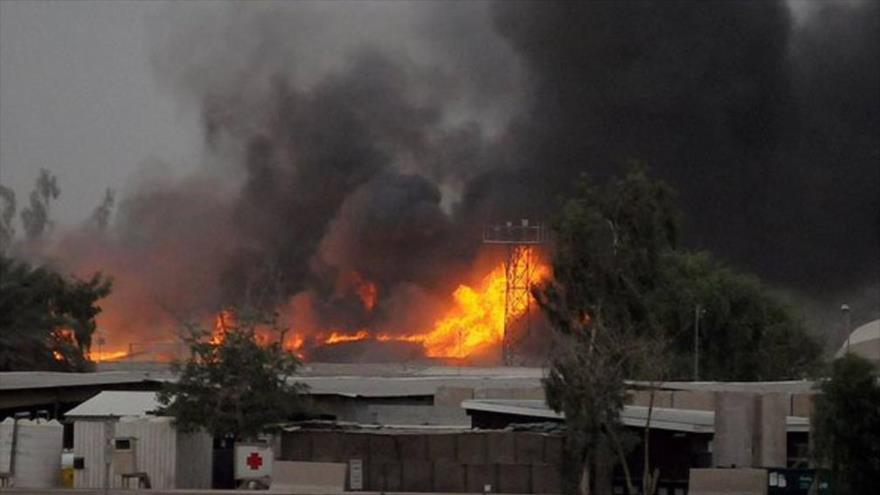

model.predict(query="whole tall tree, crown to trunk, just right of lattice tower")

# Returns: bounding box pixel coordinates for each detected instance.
[534,169,678,494]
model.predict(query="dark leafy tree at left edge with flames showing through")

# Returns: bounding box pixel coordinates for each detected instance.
[0,255,111,371]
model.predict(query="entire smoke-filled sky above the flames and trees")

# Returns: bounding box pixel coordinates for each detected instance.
[0,1,880,342]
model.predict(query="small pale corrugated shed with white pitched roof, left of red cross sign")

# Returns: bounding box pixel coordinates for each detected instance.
[67,391,213,490]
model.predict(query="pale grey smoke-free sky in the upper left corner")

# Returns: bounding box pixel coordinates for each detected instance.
[0,0,200,225]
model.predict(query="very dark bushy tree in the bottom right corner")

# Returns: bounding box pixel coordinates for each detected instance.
[812,354,880,495]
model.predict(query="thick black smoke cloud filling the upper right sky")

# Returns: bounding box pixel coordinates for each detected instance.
[484,1,880,295]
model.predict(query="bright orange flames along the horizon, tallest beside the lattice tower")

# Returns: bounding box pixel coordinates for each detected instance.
[90,248,550,361]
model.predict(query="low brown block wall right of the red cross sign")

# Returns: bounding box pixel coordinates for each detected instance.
[280,430,563,493]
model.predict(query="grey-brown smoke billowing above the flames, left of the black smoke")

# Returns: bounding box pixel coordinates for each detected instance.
[133,2,521,340]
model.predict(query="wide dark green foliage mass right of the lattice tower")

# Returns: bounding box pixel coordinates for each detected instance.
[537,168,821,381]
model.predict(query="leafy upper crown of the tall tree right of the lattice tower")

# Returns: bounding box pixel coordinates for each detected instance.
[535,169,678,344]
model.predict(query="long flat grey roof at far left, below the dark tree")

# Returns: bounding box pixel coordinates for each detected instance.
[0,371,174,390]
